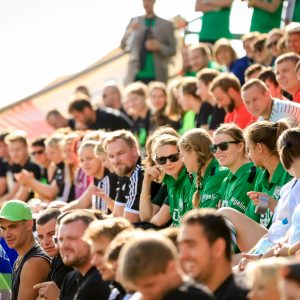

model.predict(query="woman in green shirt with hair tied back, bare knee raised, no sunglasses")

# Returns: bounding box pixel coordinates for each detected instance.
[221,121,292,251]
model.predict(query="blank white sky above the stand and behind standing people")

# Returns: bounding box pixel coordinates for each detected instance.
[0,0,251,107]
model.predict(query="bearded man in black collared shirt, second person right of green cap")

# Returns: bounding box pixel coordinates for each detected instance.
[58,211,110,300]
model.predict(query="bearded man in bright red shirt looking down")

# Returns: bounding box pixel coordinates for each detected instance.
[210,74,256,128]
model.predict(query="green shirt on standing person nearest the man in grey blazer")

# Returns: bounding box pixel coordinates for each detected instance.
[199,8,232,42]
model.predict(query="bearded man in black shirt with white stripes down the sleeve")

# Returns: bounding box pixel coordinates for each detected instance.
[104,130,144,222]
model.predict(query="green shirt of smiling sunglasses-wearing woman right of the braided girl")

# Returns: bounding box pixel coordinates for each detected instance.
[220,162,260,213]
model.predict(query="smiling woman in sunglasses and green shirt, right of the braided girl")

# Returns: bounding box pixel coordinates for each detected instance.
[210,123,259,213]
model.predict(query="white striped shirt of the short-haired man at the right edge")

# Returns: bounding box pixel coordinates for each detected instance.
[258,98,300,126]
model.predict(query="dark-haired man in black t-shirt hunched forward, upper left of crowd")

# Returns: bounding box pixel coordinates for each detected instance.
[69,99,132,131]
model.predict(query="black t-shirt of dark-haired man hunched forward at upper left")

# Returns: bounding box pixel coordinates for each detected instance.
[89,108,132,131]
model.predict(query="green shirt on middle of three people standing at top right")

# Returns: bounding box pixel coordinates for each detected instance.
[250,0,282,33]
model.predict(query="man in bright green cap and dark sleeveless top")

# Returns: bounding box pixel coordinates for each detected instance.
[0,200,50,300]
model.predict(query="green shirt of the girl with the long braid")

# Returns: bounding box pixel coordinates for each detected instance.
[190,158,229,208]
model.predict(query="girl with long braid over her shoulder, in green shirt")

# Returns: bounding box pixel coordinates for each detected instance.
[179,128,229,208]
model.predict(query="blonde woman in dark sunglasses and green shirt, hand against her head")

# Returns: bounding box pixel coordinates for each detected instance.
[144,134,192,226]
